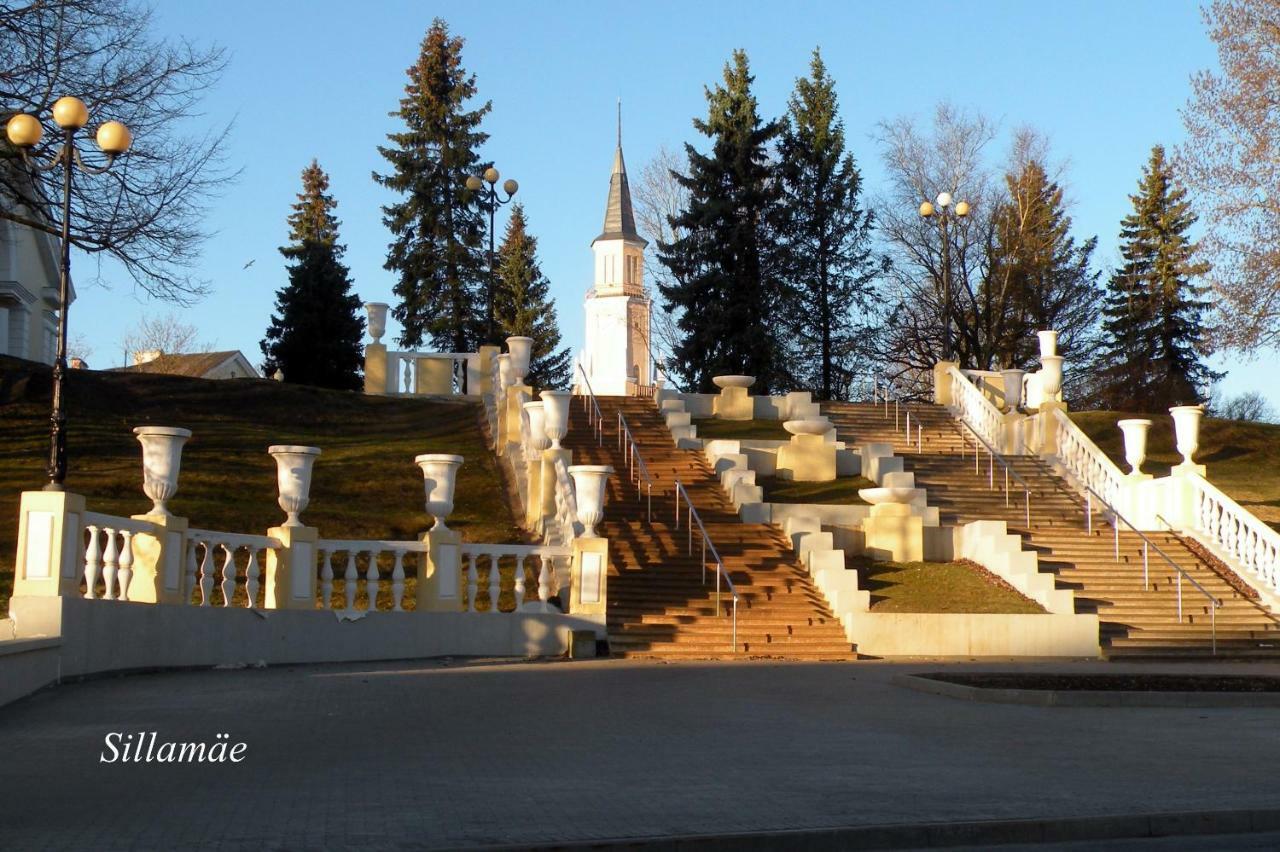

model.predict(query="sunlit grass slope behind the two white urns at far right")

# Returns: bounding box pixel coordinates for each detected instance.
[1071,411,1280,530]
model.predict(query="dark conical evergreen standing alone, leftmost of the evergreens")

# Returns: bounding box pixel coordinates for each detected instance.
[260,160,365,390]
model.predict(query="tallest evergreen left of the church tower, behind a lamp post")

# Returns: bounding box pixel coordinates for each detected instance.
[374,18,493,352]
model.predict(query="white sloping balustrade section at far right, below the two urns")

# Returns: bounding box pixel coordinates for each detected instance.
[1161,476,1280,592]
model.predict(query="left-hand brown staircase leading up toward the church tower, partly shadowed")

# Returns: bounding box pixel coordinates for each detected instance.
[563,397,856,660]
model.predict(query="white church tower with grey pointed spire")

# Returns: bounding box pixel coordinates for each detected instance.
[586,105,652,397]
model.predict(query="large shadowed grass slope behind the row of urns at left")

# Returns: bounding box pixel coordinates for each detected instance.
[0,357,525,615]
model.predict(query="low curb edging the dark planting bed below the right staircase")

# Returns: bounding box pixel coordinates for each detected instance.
[891,674,1280,707]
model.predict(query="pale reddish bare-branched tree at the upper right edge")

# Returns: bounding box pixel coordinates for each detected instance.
[1176,0,1280,351]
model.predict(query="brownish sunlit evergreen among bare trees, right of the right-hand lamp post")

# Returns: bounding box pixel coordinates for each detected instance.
[978,157,1102,367]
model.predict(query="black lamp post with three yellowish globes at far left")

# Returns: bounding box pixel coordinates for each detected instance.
[5,97,133,491]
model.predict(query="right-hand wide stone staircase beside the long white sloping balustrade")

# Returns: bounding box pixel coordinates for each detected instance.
[823,403,1280,659]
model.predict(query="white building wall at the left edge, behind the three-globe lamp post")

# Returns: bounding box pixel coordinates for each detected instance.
[0,211,65,363]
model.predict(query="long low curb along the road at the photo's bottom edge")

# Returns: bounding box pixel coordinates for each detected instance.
[467,809,1280,852]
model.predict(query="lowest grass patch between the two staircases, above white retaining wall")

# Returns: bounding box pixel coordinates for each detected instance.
[846,556,1044,613]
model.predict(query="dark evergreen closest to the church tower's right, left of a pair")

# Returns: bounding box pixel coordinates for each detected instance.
[658,50,786,393]
